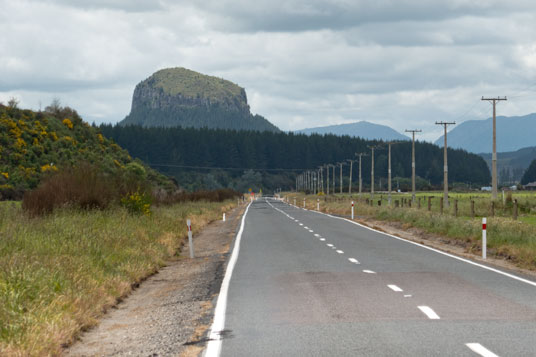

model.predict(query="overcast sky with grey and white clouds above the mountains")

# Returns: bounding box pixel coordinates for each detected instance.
[0,0,536,140]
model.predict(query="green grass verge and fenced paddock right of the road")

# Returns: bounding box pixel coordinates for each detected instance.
[287,193,536,270]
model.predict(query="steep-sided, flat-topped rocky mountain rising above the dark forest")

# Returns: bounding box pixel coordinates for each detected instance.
[120,68,280,132]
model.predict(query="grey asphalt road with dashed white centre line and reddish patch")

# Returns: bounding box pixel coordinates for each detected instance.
[206,200,536,356]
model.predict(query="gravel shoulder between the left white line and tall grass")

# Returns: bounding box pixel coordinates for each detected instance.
[64,206,245,356]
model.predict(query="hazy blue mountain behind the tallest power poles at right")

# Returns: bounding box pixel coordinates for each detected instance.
[435,113,536,153]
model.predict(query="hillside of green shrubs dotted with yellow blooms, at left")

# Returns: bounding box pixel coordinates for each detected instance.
[0,104,170,199]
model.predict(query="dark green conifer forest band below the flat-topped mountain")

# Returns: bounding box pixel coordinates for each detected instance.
[100,125,491,190]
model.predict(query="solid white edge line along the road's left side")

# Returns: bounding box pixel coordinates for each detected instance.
[205,202,251,357]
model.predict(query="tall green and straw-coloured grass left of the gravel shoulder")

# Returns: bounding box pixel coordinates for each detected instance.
[0,200,236,356]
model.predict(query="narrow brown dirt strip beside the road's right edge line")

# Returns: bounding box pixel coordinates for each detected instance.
[355,218,536,277]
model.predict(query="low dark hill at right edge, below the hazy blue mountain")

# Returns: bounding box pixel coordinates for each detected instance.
[478,145,536,184]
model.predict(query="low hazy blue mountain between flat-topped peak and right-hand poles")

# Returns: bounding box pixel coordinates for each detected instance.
[295,121,409,140]
